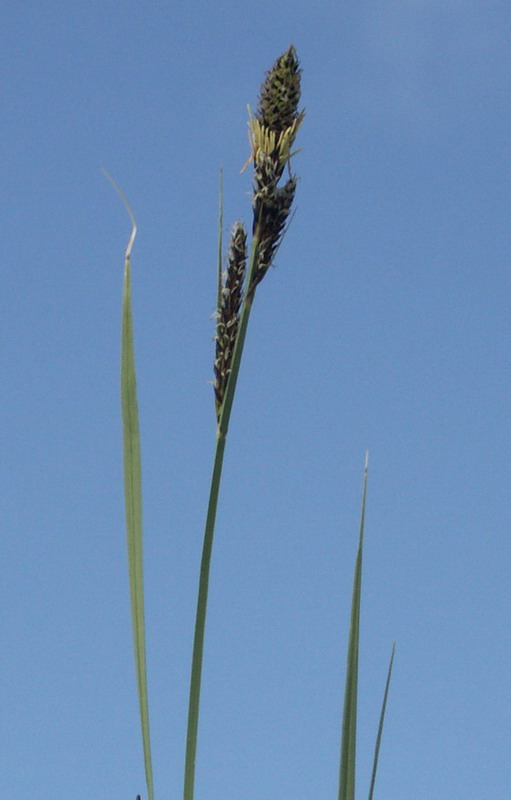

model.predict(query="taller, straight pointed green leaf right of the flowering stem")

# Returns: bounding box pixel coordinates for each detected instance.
[338,454,368,800]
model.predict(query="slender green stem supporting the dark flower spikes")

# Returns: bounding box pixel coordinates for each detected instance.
[183,237,259,800]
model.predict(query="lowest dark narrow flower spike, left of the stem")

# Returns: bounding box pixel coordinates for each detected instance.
[214,222,247,418]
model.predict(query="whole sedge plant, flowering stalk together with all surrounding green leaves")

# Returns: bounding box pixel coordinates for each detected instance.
[108,45,394,800]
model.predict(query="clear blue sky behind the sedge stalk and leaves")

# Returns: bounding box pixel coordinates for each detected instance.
[0,0,511,800]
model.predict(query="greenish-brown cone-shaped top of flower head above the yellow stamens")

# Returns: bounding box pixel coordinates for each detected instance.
[256,45,301,134]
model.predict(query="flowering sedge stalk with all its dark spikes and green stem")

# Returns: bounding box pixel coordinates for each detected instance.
[183,45,304,800]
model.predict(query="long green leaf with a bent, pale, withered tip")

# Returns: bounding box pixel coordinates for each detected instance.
[105,172,154,800]
